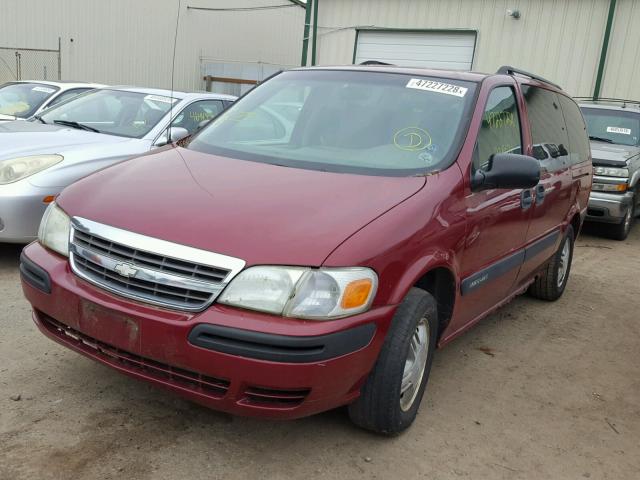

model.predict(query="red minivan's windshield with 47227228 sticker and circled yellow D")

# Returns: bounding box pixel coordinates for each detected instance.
[188,70,476,176]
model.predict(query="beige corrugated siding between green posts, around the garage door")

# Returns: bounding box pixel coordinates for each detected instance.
[318,0,616,95]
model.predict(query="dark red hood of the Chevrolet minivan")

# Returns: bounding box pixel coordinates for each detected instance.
[58,148,426,266]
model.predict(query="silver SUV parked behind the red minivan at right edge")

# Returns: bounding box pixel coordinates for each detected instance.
[580,98,640,240]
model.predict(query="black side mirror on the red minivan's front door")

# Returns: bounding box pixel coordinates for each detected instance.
[471,153,540,191]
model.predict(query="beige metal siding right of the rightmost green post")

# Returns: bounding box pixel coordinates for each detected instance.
[601,0,640,100]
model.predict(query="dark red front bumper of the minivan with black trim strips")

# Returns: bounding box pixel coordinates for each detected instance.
[22,243,395,418]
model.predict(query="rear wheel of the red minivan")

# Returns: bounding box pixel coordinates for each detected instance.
[529,225,574,302]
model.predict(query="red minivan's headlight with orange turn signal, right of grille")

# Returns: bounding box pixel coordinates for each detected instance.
[218,266,378,320]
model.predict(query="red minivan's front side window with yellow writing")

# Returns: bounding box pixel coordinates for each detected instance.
[473,87,522,170]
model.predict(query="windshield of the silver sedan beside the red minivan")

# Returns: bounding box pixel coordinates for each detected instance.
[40,89,178,138]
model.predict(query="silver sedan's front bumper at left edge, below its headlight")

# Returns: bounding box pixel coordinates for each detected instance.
[0,180,59,243]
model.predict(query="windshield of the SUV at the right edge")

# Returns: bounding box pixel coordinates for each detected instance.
[582,107,640,146]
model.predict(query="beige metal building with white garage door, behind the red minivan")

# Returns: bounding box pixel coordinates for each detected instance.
[308,0,640,99]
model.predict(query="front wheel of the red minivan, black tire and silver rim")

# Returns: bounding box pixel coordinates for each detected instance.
[349,288,438,435]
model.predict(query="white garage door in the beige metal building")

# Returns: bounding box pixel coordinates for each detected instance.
[355,30,476,70]
